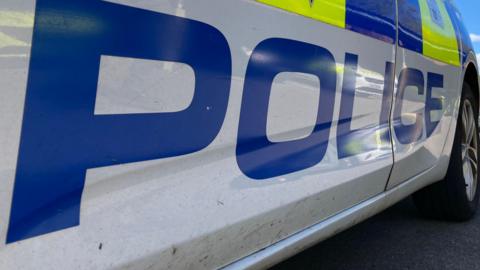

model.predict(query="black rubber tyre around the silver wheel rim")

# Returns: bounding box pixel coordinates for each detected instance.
[413,83,480,221]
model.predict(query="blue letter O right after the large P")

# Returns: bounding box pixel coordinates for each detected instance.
[237,38,337,179]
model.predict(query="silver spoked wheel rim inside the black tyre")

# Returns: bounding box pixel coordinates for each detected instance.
[462,99,478,201]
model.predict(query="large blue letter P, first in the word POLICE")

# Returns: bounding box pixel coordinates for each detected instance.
[7,0,231,243]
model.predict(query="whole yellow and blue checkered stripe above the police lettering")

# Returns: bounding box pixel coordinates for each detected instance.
[257,0,461,66]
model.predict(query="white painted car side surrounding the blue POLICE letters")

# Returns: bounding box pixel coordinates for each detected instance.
[0,0,474,269]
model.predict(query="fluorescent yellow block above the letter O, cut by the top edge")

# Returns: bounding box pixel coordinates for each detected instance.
[257,0,346,28]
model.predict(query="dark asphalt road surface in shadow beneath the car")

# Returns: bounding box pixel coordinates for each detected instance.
[272,198,480,270]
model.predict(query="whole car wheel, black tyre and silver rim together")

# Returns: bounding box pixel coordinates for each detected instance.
[413,83,479,221]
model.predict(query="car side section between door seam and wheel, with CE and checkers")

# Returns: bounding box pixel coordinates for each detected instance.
[388,0,463,188]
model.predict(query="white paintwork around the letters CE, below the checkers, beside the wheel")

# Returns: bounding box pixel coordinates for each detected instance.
[388,48,461,188]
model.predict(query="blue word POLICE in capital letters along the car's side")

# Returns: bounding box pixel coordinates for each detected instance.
[7,0,443,243]
